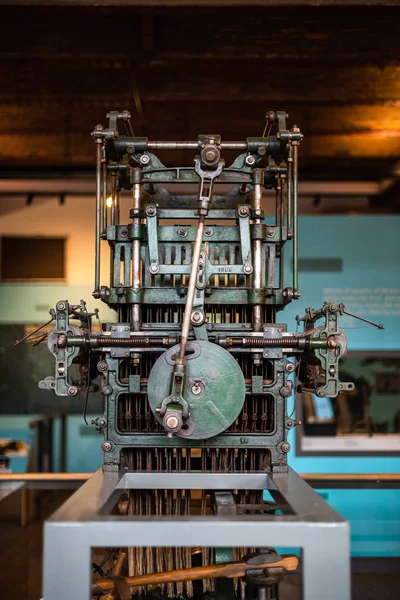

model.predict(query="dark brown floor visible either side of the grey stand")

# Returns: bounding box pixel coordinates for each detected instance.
[0,491,400,600]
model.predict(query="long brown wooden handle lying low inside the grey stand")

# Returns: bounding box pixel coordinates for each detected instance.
[94,554,299,592]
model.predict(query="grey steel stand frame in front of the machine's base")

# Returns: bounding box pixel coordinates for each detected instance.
[43,469,350,600]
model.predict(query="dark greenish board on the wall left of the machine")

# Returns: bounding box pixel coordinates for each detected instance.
[0,325,102,415]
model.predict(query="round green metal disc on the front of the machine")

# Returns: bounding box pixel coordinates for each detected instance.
[147,341,246,440]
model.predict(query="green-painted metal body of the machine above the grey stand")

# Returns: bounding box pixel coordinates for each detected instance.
[36,111,349,470]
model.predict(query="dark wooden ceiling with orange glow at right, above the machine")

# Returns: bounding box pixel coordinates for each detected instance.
[0,6,400,179]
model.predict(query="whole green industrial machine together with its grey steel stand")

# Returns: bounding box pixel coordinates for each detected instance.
[39,111,353,600]
